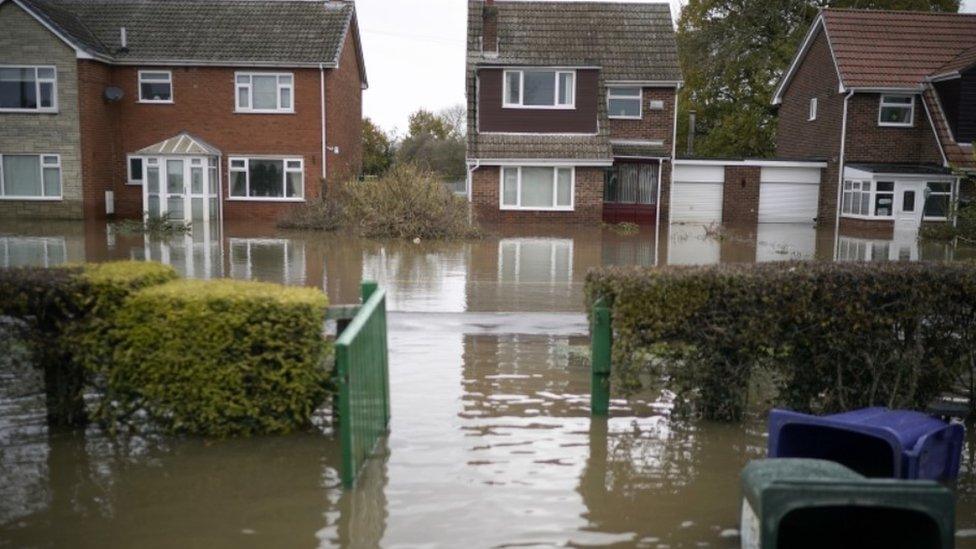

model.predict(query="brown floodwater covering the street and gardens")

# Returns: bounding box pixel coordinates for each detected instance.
[0,222,976,548]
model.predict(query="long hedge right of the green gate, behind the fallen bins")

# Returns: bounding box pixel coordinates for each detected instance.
[586,263,976,419]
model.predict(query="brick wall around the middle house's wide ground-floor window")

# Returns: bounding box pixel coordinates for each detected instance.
[471,166,604,225]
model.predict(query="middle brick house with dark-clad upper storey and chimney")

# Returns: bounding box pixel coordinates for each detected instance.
[466,0,682,223]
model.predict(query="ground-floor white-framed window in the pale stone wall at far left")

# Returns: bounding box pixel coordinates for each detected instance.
[0,154,61,200]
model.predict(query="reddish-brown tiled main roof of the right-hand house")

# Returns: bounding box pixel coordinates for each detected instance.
[823,9,976,88]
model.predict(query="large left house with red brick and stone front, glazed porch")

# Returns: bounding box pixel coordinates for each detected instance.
[0,0,366,221]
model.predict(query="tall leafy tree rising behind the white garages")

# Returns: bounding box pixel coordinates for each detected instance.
[677,0,959,156]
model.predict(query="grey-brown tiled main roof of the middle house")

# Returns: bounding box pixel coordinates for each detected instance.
[468,0,681,81]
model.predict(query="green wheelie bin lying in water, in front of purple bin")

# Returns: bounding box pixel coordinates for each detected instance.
[740,458,955,549]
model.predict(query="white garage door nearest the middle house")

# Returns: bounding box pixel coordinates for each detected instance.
[671,165,725,223]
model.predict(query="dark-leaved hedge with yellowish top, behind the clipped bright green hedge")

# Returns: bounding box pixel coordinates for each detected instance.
[0,261,176,426]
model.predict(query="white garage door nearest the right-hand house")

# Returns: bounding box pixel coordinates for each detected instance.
[759,168,820,223]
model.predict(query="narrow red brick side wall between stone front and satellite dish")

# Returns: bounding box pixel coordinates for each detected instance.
[78,60,120,218]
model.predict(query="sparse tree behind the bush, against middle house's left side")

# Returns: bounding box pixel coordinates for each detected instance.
[397,105,466,180]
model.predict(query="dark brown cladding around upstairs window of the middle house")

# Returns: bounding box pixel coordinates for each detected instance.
[478,68,600,134]
